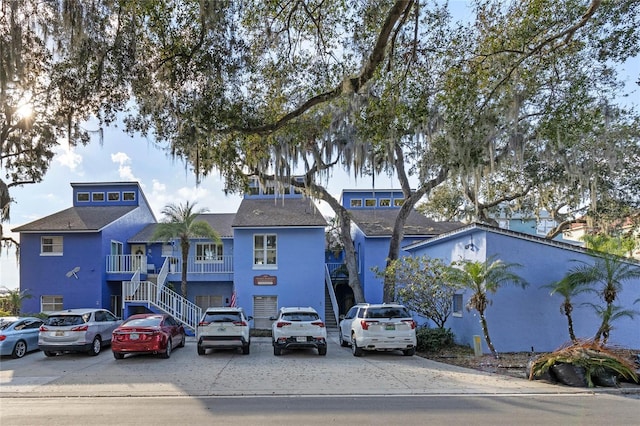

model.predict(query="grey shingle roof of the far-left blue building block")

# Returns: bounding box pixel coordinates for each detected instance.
[12,206,138,233]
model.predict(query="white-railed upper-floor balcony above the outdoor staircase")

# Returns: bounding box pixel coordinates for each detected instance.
[106,254,233,274]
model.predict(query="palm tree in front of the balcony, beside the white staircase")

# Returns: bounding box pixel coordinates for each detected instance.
[151,201,220,299]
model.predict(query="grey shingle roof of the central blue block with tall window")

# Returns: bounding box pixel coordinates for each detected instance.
[231,198,327,228]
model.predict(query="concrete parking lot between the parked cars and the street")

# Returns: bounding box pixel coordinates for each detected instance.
[0,334,608,398]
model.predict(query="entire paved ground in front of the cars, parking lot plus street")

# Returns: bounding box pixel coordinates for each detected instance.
[0,336,640,426]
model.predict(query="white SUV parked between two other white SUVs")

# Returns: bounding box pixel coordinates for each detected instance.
[271,307,327,355]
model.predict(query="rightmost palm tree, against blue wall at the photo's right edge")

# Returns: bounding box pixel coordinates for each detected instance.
[567,238,640,342]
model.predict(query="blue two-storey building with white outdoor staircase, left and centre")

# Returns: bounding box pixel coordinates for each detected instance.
[14,182,327,329]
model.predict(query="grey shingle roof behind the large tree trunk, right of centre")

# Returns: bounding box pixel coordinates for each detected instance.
[349,209,464,237]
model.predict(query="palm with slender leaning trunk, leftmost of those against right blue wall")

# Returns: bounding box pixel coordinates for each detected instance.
[454,257,527,358]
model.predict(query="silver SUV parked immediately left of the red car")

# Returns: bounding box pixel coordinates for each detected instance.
[38,308,122,356]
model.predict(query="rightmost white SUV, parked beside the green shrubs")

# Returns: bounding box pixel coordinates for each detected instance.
[339,303,416,356]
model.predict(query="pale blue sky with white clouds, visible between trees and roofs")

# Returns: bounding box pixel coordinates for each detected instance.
[0,1,640,289]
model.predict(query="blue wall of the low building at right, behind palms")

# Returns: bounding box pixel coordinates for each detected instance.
[412,230,640,352]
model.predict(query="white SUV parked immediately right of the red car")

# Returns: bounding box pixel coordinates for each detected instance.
[197,308,253,355]
